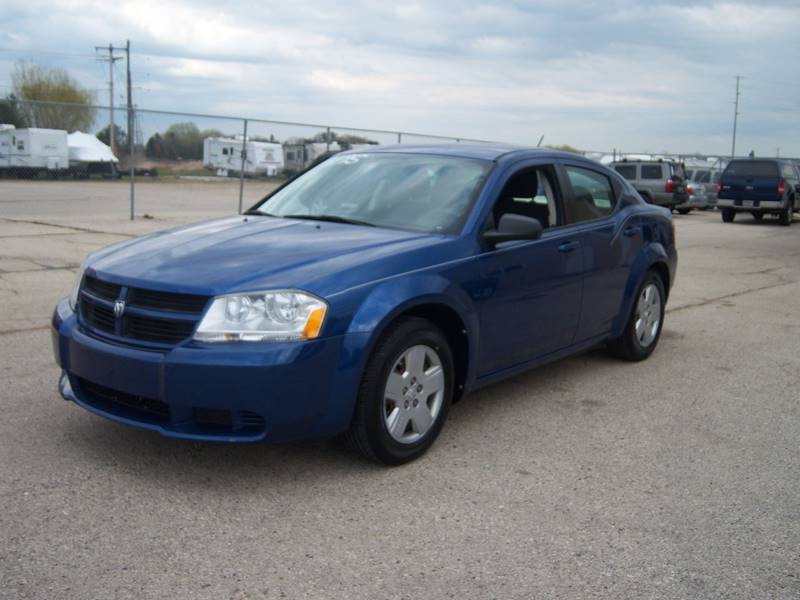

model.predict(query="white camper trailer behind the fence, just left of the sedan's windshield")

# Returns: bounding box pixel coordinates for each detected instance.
[203,138,283,177]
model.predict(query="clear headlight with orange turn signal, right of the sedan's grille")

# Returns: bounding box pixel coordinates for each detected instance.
[194,290,328,342]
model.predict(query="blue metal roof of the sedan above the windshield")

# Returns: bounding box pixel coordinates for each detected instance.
[347,142,589,161]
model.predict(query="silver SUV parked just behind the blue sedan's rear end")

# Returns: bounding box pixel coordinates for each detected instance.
[609,159,689,212]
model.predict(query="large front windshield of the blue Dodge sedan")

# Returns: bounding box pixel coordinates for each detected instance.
[251,153,492,233]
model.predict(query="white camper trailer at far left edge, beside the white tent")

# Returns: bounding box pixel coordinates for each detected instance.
[0,128,69,177]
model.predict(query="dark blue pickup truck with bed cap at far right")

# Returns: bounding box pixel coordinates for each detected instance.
[717,158,800,225]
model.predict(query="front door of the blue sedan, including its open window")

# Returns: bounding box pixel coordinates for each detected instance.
[478,165,583,377]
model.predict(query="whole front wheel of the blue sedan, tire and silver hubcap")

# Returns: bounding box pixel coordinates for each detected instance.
[345,317,455,465]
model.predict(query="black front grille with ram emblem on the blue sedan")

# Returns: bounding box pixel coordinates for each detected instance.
[79,275,209,345]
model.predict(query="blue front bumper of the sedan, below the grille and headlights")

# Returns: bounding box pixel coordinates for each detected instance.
[52,300,368,442]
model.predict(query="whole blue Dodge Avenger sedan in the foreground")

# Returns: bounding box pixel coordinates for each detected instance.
[52,144,677,464]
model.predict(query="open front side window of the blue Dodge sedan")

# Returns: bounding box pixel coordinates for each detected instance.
[492,167,563,229]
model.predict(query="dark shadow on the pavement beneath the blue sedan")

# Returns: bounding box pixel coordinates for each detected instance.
[59,349,620,493]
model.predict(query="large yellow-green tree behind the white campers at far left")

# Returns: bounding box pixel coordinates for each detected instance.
[11,62,95,131]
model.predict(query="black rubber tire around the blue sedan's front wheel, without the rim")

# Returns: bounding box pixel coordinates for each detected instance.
[344,317,455,465]
